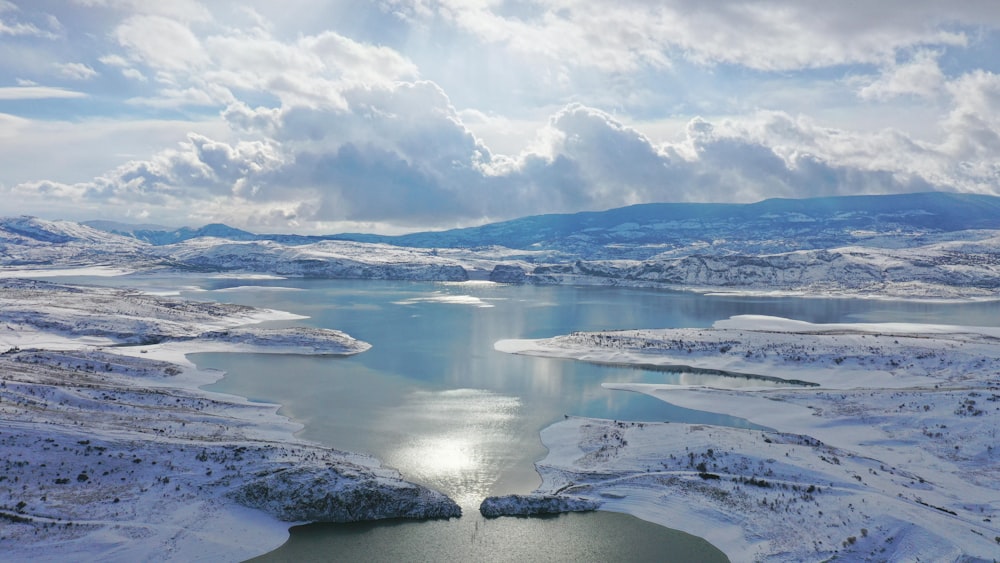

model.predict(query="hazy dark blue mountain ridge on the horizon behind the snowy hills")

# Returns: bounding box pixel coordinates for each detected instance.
[84,192,1000,260]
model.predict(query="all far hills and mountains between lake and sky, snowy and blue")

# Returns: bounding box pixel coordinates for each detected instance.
[0,193,1000,299]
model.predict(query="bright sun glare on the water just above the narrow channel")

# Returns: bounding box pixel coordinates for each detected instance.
[376,389,521,507]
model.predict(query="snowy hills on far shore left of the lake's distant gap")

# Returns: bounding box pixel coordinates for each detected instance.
[0,217,484,281]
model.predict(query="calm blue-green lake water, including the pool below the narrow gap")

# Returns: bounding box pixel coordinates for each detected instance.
[80,272,1000,561]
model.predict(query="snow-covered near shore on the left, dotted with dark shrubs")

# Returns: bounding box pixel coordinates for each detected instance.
[0,280,460,561]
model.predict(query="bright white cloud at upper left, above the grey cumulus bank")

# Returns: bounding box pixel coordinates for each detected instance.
[100,11,419,114]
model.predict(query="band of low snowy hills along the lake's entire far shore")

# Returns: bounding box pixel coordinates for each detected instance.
[9,217,1000,300]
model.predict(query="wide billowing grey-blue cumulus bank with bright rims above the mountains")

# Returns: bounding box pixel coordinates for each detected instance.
[5,92,944,228]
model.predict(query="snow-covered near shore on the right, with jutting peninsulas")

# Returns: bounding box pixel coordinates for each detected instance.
[496,316,1000,561]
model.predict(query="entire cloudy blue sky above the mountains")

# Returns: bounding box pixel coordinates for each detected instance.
[0,0,1000,234]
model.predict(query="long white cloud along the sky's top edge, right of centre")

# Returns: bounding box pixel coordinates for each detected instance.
[388,0,1000,71]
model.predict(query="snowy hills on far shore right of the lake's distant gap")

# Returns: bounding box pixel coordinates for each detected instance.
[512,231,1000,297]
